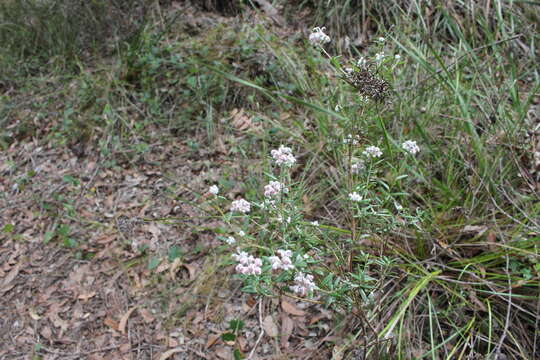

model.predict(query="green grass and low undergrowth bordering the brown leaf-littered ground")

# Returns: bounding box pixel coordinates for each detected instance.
[0,0,540,360]
